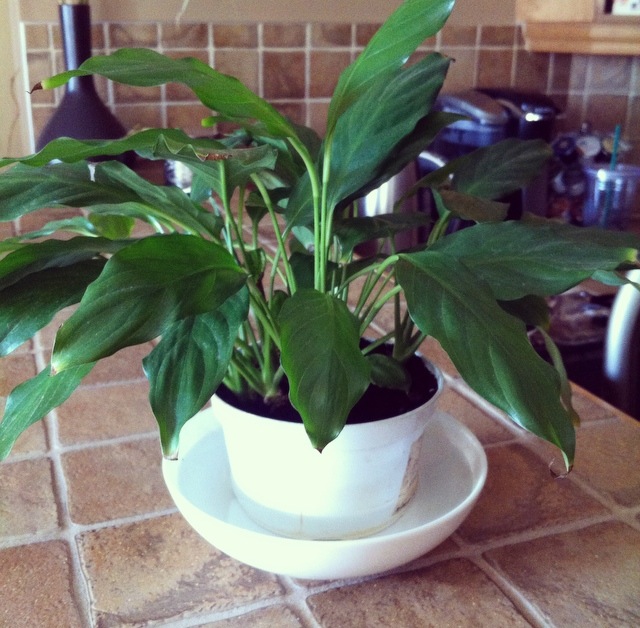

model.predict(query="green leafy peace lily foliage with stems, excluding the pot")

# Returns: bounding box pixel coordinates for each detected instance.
[0,0,638,476]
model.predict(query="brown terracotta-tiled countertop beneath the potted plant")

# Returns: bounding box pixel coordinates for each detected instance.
[0,185,640,628]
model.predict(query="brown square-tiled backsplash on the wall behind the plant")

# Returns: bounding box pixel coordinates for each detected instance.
[24,22,640,163]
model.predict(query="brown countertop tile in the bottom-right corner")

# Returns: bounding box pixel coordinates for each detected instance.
[487,522,640,626]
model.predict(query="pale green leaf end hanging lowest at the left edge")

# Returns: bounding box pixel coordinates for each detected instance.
[0,364,93,460]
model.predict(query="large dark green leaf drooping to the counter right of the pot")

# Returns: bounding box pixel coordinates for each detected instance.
[397,251,575,467]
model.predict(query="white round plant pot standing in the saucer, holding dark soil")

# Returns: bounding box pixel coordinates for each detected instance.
[218,364,443,540]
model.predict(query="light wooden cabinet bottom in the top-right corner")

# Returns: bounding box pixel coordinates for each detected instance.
[516,0,640,55]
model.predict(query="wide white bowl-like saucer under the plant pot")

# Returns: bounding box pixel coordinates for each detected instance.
[163,409,487,580]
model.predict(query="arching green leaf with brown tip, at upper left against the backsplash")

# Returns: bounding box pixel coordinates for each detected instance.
[33,48,296,137]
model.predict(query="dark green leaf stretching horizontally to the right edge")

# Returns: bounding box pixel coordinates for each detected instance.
[431,221,640,300]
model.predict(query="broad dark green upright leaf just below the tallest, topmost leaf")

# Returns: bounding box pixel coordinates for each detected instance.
[327,53,451,212]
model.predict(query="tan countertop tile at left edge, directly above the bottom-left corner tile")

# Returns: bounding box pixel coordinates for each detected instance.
[0,458,58,537]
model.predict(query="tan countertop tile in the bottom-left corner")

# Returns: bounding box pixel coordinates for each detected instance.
[0,541,83,628]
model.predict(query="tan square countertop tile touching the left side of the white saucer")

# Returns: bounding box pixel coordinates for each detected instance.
[62,438,173,524]
